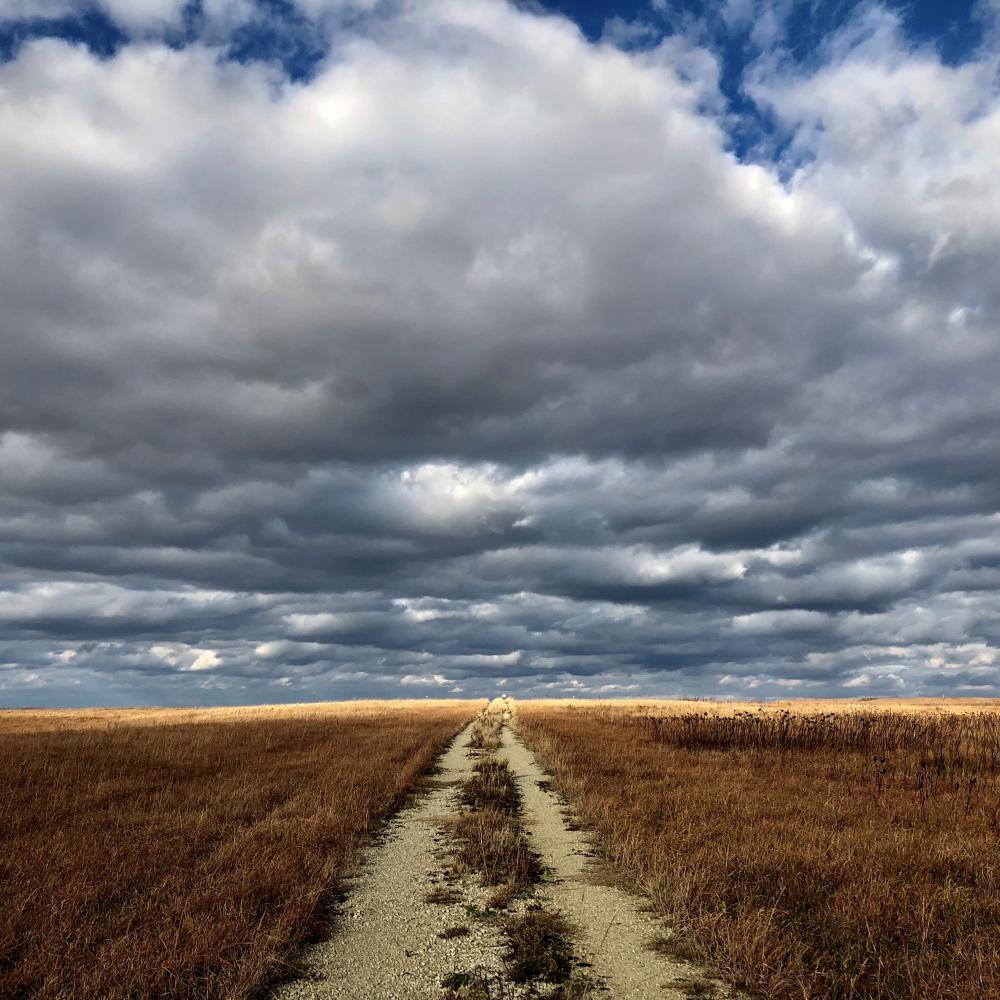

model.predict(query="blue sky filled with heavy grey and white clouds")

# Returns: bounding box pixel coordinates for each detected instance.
[0,0,1000,706]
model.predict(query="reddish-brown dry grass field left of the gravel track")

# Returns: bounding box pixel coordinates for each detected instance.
[0,702,478,1000]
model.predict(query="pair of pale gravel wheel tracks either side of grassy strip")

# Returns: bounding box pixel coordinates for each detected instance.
[274,728,730,1000]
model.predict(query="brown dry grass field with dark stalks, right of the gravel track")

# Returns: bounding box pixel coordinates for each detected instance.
[519,702,1000,1000]
